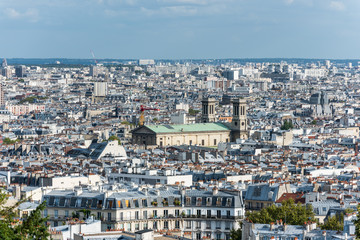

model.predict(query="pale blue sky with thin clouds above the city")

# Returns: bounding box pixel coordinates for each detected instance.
[0,0,360,59]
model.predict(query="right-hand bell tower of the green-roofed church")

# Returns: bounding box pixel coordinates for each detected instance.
[231,98,248,140]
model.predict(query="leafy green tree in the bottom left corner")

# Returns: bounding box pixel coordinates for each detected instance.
[0,191,50,240]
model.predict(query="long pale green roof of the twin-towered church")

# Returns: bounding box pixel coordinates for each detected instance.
[146,123,230,133]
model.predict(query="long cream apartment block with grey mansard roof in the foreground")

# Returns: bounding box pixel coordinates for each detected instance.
[43,188,244,239]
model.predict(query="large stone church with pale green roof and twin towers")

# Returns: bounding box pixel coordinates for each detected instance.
[132,98,248,147]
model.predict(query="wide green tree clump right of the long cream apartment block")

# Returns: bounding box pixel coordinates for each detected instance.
[247,199,315,225]
